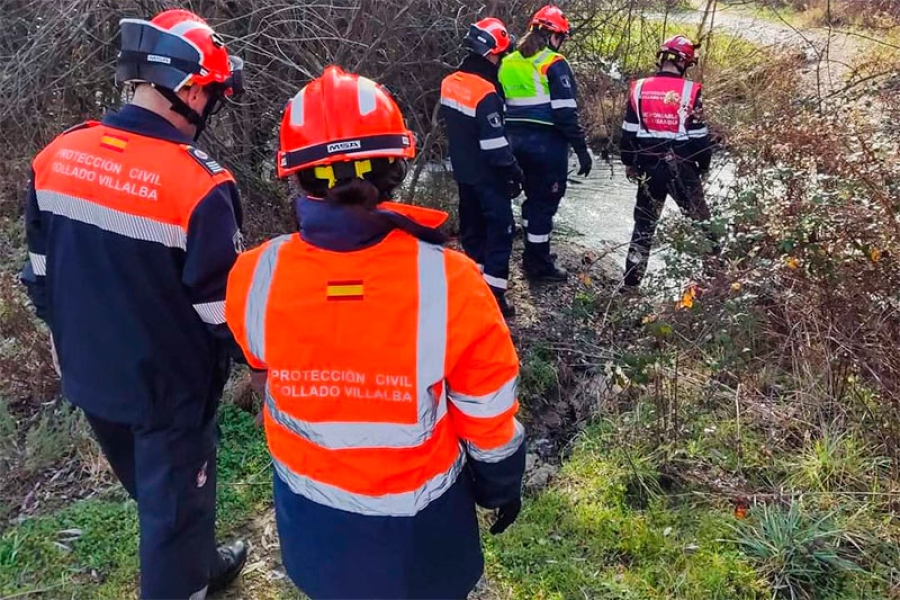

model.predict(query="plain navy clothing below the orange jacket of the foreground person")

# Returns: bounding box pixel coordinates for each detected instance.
[275,472,484,600]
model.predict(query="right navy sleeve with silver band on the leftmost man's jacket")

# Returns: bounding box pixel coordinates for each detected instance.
[182,181,243,360]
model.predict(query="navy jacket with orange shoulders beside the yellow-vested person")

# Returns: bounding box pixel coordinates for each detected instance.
[440,54,522,185]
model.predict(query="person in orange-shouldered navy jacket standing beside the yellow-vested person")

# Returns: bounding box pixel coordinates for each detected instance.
[441,17,524,317]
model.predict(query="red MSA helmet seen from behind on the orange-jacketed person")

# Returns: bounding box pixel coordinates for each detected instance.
[277,66,416,177]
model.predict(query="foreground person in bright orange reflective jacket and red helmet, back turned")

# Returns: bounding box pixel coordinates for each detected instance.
[225,66,525,599]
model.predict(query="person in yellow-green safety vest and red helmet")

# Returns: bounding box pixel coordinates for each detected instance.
[500,4,593,281]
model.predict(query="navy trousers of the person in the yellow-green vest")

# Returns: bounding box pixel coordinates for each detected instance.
[508,125,569,270]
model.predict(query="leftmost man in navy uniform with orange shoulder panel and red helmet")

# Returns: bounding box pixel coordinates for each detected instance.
[22,10,247,599]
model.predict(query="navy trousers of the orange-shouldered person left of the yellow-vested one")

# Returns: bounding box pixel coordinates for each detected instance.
[459,183,513,291]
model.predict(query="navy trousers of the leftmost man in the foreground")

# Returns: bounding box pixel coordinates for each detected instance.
[85,413,218,600]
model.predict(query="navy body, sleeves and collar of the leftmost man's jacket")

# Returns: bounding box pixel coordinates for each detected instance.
[22,105,242,427]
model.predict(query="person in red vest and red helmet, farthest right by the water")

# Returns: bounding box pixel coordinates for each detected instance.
[621,35,715,289]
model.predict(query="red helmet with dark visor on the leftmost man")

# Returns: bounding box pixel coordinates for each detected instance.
[116,9,243,96]
